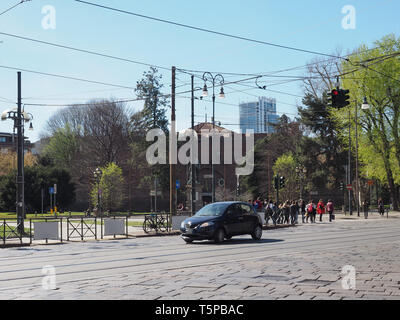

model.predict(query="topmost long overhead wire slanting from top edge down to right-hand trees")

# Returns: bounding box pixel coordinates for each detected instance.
[73,0,346,60]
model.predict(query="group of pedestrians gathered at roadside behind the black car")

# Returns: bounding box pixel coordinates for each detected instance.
[258,199,335,225]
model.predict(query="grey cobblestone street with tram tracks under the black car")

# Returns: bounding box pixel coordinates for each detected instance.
[0,219,400,300]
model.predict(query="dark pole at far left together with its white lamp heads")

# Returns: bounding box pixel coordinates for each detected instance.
[1,72,33,235]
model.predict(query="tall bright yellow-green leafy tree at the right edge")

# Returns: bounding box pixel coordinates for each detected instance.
[332,35,400,210]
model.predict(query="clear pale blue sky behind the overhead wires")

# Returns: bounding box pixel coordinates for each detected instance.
[0,0,400,141]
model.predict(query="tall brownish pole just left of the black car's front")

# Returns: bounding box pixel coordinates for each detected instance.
[169,67,177,229]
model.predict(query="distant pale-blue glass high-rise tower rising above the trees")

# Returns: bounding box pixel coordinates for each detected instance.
[239,97,279,133]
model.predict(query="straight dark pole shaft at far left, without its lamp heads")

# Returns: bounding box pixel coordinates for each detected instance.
[16,72,25,234]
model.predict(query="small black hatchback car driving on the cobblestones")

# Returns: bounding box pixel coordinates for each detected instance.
[180,202,262,243]
